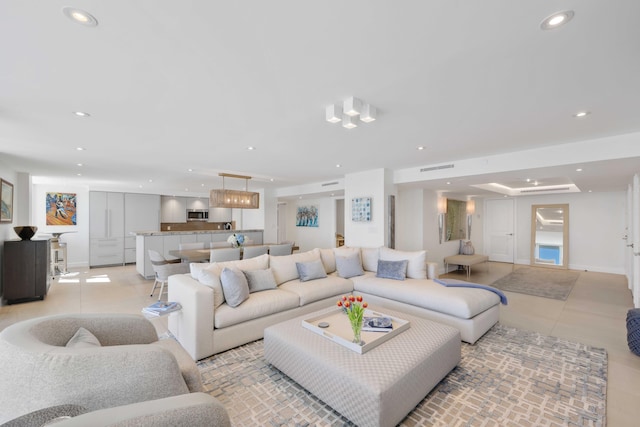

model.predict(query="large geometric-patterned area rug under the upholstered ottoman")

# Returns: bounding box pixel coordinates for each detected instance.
[198,325,607,426]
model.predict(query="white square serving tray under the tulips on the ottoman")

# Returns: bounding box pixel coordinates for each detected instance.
[302,307,410,354]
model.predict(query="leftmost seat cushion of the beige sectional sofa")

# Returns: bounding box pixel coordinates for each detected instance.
[213,289,300,329]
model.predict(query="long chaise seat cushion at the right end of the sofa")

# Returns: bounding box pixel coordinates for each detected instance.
[352,273,500,319]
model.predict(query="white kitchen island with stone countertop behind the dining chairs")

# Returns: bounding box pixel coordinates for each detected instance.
[135,230,263,279]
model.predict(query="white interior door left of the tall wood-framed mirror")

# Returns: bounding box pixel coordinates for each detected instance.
[485,199,514,264]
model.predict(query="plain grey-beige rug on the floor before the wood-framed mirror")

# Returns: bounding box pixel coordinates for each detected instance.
[491,267,580,301]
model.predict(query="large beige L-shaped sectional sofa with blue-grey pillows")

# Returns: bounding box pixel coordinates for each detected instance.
[168,246,500,360]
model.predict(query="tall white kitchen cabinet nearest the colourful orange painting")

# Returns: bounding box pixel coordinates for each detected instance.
[89,191,124,267]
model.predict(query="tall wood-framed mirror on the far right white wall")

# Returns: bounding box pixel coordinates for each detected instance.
[531,204,569,268]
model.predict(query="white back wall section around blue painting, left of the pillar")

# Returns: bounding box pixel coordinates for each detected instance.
[286,197,336,252]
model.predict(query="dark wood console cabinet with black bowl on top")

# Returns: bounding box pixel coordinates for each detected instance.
[2,240,51,304]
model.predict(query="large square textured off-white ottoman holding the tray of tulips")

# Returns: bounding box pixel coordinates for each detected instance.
[264,308,460,427]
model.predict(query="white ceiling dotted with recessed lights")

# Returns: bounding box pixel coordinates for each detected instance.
[0,0,640,199]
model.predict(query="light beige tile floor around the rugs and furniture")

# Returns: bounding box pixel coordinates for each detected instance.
[0,262,640,427]
